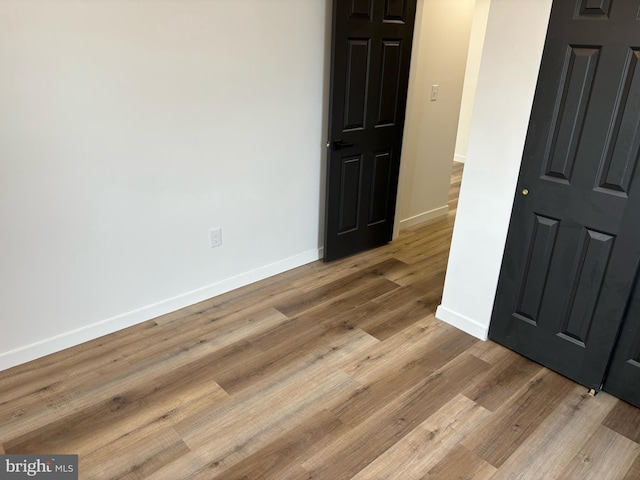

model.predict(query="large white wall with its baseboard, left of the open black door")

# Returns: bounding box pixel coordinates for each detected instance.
[0,0,328,369]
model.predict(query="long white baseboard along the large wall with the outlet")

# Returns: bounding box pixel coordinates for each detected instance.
[0,249,322,371]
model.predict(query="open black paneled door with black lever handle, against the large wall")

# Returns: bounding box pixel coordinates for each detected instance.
[324,0,416,261]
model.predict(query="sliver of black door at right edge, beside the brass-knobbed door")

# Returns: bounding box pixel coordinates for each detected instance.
[604,268,640,407]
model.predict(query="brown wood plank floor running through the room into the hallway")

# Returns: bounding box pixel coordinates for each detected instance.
[0,165,640,480]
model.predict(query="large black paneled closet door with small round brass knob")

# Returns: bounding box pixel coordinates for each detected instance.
[489,0,640,389]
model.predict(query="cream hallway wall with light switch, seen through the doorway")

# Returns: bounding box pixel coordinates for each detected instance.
[396,0,475,233]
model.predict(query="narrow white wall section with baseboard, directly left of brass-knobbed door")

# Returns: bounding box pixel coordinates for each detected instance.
[436,0,551,339]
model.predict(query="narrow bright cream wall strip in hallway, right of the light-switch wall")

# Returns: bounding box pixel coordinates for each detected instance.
[454,0,491,163]
